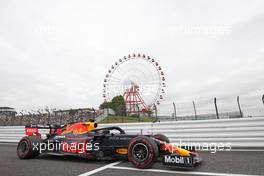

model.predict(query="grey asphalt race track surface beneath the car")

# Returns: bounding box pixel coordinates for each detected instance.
[0,144,264,176]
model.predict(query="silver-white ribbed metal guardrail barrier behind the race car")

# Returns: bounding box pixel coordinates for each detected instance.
[0,117,264,149]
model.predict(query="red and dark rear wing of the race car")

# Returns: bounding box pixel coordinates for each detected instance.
[25,124,64,136]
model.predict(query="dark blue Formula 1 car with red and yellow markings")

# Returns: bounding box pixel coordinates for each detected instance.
[17,121,202,169]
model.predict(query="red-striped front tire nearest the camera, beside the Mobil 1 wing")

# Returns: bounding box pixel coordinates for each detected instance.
[128,136,159,169]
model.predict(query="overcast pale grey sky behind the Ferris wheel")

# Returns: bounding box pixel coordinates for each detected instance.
[0,0,264,117]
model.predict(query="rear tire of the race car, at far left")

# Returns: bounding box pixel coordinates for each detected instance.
[17,136,42,159]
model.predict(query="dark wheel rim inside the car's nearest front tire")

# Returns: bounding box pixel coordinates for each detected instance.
[132,143,149,162]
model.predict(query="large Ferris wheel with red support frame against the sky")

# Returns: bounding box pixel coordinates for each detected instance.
[102,54,166,114]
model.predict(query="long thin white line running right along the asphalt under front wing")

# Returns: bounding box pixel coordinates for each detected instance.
[108,166,257,176]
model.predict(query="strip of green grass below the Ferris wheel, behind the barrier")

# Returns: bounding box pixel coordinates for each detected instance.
[99,116,155,123]
